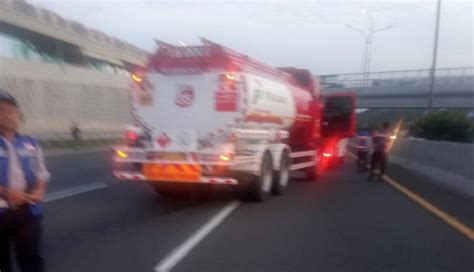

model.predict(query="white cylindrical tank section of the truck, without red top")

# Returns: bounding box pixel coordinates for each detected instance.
[131,69,311,151]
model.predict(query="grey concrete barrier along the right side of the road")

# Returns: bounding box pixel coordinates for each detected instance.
[389,139,474,199]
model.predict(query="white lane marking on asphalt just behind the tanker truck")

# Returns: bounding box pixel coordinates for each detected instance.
[155,201,240,272]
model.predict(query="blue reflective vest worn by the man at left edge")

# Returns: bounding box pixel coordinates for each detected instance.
[0,135,41,215]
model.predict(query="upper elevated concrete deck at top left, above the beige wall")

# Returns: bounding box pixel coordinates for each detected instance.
[0,0,148,66]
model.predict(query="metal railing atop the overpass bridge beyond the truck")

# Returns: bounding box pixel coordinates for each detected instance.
[319,67,474,89]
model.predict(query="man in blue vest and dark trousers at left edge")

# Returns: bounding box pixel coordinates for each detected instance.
[0,90,50,272]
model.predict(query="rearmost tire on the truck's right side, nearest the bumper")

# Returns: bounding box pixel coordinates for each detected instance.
[251,151,273,202]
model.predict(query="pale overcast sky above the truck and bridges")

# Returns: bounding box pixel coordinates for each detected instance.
[28,0,474,74]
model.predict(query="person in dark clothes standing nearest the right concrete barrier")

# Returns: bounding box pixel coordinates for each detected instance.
[368,122,390,181]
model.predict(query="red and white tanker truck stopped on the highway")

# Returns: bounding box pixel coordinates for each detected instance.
[113,38,355,201]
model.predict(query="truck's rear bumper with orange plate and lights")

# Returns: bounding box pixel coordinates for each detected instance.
[112,146,259,185]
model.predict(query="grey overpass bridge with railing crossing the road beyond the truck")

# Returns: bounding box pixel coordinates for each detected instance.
[319,67,474,109]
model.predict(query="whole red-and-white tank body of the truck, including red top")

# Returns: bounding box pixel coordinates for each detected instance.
[130,41,319,151]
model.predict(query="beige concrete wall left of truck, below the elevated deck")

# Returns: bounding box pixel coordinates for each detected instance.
[0,58,131,138]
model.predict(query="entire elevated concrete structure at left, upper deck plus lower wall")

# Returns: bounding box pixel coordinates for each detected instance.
[0,0,149,139]
